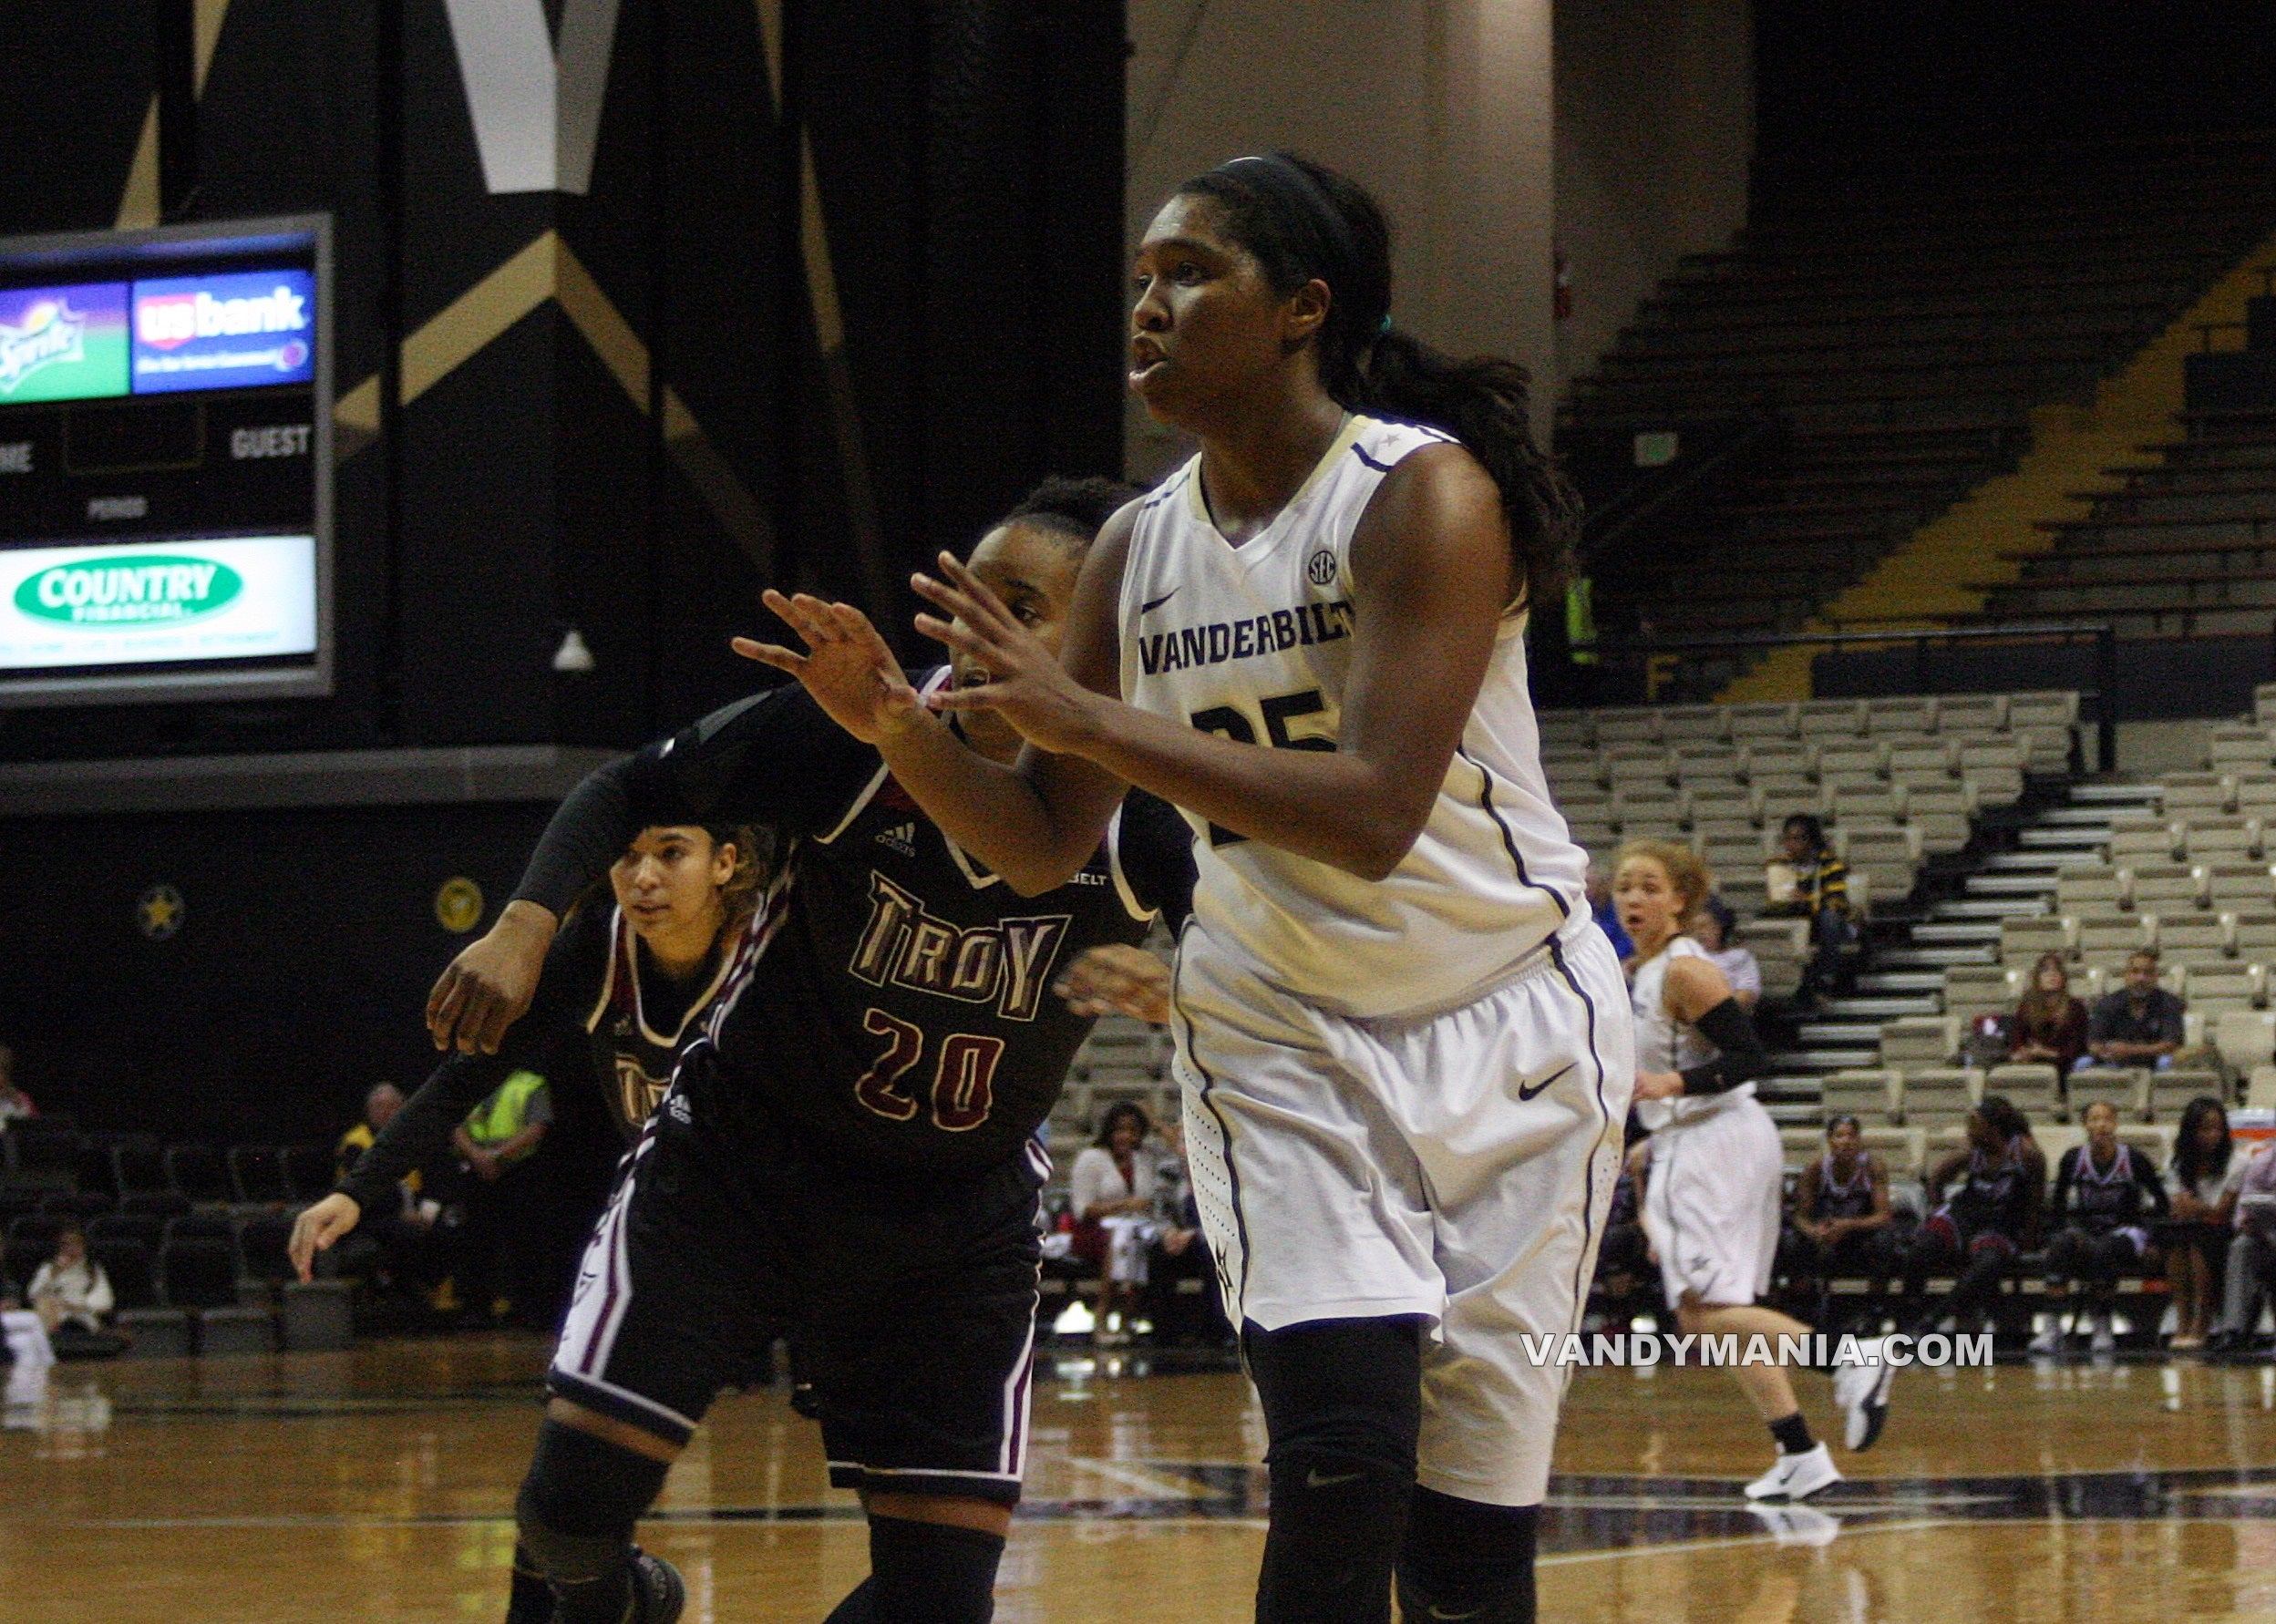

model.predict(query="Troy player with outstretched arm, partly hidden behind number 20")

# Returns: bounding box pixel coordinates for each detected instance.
[292,823,771,1624]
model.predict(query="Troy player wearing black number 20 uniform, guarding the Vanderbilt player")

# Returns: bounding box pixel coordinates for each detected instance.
[332,480,1192,1624]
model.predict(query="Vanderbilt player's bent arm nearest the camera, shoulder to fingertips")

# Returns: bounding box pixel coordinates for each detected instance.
[915,446,1511,882]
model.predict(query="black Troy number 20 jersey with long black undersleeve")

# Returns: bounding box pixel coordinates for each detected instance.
[519,671,1192,1171]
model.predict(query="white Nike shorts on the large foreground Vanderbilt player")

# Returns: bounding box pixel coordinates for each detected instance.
[1172,921,1636,1506]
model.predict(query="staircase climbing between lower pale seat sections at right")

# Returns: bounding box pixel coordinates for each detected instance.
[1762,780,2158,1125]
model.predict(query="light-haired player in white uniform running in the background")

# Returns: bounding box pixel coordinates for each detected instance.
[1612,839,1894,1499]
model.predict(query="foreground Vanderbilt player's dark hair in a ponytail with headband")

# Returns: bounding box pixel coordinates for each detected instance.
[1177,152,1580,605]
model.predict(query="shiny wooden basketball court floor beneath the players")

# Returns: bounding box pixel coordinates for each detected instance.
[17,1340,2276,1624]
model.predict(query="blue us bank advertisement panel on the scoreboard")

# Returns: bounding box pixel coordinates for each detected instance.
[134,271,316,396]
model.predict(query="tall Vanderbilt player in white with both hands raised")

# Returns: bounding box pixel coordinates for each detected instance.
[742,155,1634,1624]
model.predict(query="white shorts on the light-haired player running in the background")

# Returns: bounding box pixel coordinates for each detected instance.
[1643,1094,1785,1308]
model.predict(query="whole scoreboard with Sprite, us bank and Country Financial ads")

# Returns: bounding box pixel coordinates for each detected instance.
[0,216,333,705]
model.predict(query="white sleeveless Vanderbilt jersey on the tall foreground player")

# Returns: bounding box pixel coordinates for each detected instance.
[1120,416,1586,1017]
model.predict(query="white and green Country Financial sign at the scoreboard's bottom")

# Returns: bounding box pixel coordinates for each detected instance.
[0,537,316,671]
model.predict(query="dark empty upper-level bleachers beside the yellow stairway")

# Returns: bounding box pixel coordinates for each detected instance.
[1559,146,2276,632]
